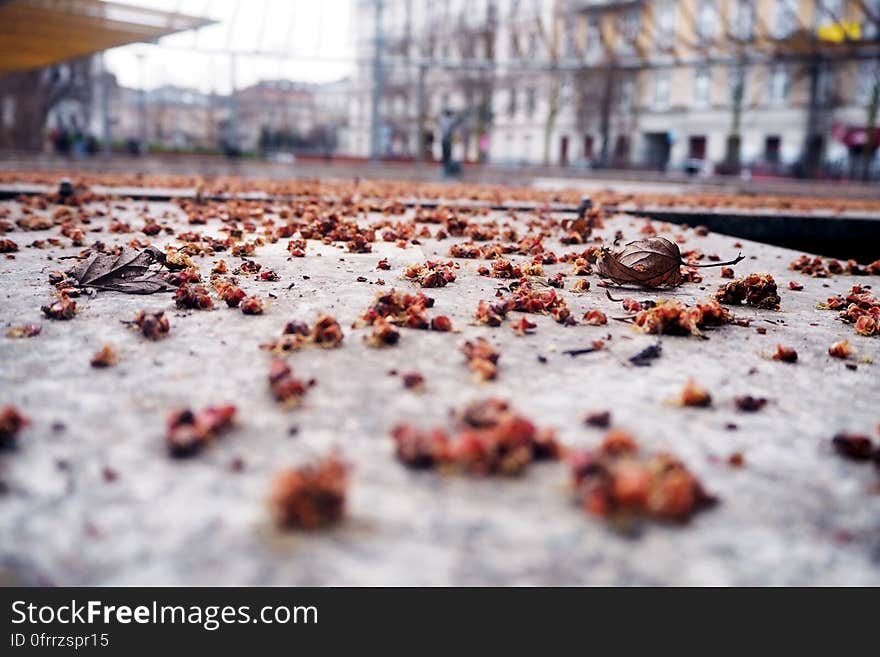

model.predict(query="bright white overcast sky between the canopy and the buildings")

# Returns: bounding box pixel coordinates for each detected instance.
[106,0,353,93]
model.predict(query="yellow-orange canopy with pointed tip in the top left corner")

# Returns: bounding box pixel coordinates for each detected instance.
[0,0,215,74]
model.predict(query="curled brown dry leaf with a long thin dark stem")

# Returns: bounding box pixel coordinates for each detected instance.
[596,237,744,287]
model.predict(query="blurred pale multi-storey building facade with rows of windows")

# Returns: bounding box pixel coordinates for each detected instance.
[349,0,880,174]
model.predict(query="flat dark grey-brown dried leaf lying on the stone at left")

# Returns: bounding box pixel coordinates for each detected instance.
[71,247,174,294]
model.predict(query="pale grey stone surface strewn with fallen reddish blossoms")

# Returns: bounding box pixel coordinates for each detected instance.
[0,196,880,585]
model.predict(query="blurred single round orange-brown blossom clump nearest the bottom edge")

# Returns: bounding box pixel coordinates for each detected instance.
[269,454,349,530]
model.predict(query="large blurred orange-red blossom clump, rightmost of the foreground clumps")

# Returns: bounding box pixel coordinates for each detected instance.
[569,430,716,521]
